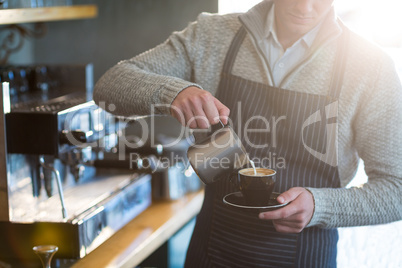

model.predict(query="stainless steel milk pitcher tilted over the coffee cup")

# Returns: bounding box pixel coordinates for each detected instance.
[187,122,248,184]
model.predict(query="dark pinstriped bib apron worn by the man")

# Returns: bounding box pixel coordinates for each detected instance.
[186,27,346,268]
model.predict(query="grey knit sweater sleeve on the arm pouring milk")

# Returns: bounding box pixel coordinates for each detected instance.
[93,16,201,116]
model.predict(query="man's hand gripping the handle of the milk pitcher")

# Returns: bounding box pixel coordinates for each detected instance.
[170,86,230,128]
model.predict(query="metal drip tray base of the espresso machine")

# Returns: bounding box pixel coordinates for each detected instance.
[0,174,152,259]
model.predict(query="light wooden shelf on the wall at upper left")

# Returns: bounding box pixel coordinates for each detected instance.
[0,5,98,25]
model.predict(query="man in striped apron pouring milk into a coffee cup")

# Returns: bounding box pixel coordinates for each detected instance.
[94,0,402,267]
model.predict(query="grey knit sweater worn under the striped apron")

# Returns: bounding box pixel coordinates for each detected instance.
[94,1,402,228]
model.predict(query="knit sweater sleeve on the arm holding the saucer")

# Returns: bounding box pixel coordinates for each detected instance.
[308,54,402,228]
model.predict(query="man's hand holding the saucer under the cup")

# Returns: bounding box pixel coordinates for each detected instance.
[259,187,314,233]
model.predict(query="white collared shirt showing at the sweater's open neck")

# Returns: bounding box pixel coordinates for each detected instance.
[260,5,321,86]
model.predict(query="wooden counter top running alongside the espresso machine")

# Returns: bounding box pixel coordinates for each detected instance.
[72,190,204,268]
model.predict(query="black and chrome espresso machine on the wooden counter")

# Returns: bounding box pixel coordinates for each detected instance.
[0,64,154,262]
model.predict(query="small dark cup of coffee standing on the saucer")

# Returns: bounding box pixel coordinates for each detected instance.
[238,168,276,207]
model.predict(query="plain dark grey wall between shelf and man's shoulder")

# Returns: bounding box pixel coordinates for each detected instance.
[10,0,218,81]
